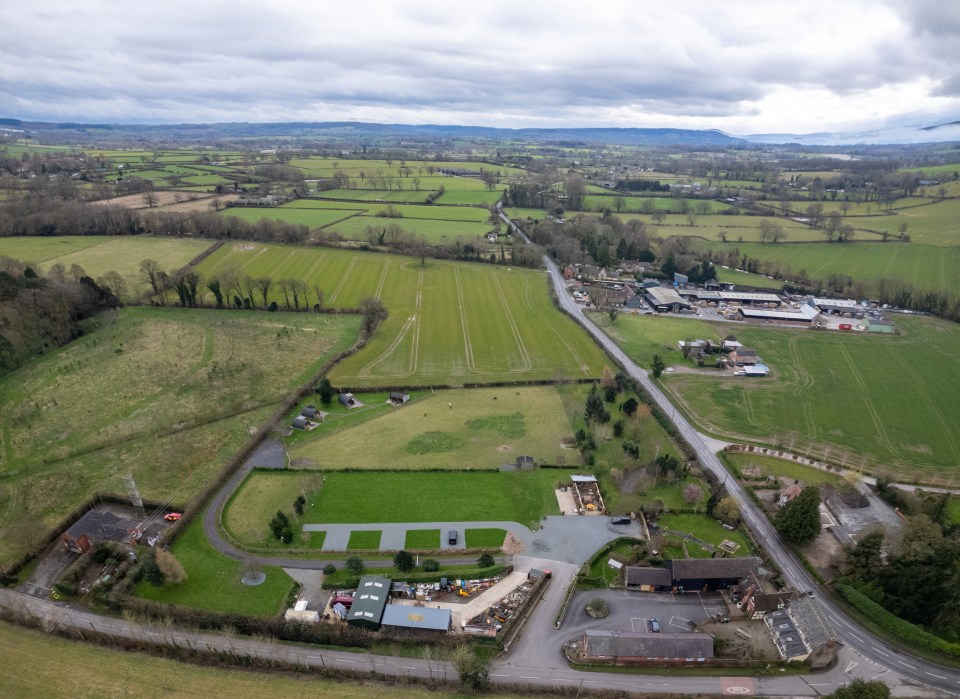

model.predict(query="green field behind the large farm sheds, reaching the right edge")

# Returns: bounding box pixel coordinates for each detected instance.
[701,242,960,295]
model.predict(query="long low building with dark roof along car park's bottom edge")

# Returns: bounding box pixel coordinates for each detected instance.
[579,630,713,665]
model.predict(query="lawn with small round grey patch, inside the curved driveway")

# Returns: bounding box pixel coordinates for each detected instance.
[135,515,294,616]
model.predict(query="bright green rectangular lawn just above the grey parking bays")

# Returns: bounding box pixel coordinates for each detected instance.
[300,469,573,524]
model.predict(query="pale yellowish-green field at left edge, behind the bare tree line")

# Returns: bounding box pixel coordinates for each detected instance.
[0,236,213,288]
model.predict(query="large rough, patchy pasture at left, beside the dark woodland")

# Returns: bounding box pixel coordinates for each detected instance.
[0,308,359,560]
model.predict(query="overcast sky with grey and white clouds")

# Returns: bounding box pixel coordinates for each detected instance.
[0,0,960,134]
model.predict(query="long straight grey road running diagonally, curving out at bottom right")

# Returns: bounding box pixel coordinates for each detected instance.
[500,213,960,693]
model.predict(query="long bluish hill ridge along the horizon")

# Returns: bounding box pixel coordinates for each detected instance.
[0,119,746,147]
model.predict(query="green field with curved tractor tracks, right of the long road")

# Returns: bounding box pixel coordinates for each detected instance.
[666,316,960,484]
